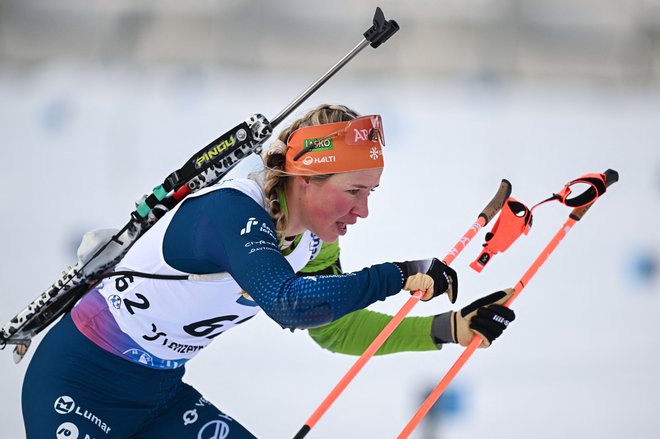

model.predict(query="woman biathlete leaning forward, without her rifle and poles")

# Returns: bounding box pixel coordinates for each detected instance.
[22,105,514,439]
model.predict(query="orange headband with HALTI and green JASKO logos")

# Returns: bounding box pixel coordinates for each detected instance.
[284,115,385,175]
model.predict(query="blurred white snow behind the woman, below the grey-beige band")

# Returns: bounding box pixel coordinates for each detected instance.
[0,1,660,439]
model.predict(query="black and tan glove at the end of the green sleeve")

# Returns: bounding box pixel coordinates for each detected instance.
[431,288,516,348]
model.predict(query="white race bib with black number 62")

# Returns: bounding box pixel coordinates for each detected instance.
[100,179,321,361]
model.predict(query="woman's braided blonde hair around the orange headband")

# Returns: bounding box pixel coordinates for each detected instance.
[262,104,359,239]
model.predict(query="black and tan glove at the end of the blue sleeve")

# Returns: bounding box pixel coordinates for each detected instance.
[394,258,458,303]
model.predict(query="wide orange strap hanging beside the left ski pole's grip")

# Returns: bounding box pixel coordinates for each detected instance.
[470,197,532,272]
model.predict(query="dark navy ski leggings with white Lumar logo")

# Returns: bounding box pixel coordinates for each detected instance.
[22,314,254,439]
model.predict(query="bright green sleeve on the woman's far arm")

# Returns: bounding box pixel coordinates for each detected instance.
[301,240,438,355]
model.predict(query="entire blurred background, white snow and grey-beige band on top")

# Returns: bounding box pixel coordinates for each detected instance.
[0,0,660,439]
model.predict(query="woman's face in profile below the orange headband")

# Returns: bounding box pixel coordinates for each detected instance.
[296,169,383,242]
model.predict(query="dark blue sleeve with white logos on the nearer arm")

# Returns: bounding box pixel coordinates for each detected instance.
[163,189,403,329]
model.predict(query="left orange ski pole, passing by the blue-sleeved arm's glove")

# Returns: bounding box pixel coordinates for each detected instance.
[294,179,511,439]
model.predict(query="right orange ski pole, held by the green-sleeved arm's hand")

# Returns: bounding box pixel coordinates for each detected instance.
[397,169,619,439]
